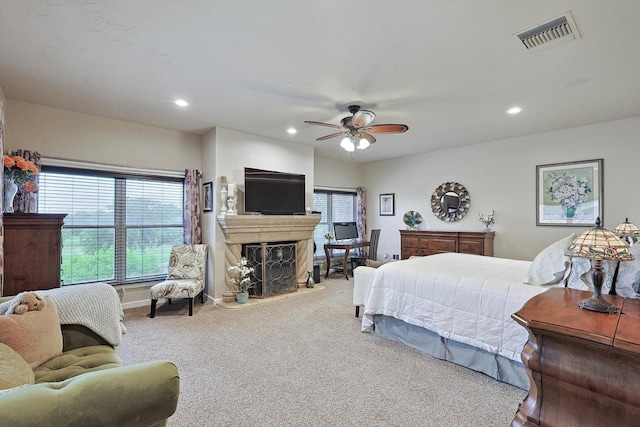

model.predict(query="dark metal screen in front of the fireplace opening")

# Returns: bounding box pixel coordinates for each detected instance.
[245,243,298,298]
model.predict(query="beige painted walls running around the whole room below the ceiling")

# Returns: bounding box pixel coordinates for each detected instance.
[5,95,640,306]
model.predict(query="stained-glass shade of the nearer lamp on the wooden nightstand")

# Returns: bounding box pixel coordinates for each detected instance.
[565,218,634,261]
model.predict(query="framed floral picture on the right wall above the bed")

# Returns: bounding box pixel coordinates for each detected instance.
[536,159,604,227]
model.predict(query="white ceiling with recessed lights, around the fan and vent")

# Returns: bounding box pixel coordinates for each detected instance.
[0,0,640,162]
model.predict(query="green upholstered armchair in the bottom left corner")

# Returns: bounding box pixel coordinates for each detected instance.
[0,291,180,427]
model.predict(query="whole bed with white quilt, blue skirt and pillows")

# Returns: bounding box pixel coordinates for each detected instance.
[360,234,640,389]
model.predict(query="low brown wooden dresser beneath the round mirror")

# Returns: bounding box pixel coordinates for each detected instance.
[400,230,495,259]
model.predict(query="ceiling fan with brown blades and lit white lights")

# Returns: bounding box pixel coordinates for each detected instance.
[305,105,409,151]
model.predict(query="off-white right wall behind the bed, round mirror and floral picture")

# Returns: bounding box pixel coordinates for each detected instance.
[364,117,640,260]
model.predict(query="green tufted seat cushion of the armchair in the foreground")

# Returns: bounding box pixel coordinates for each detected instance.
[34,345,122,383]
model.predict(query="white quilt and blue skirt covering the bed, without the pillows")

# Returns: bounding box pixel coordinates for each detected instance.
[356,253,563,389]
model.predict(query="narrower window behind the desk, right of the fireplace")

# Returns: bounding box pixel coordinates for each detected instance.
[313,190,358,257]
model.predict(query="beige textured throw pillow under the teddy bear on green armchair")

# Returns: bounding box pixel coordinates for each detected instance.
[0,296,62,368]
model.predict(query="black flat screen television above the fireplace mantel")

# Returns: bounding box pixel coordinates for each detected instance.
[244,168,305,215]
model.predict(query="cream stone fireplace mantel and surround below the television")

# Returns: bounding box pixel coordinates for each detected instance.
[217,214,321,301]
